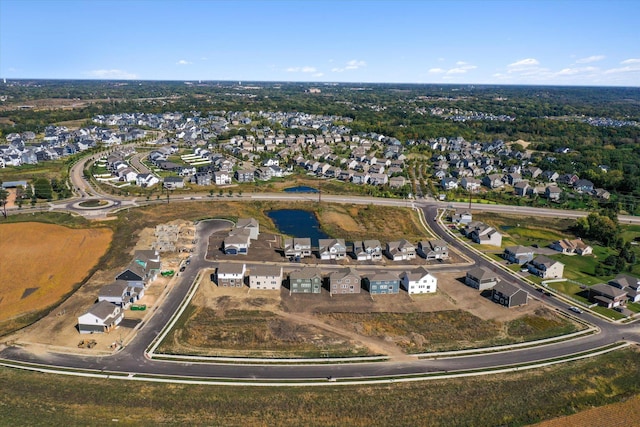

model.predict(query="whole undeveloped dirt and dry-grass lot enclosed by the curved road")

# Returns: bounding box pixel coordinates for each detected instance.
[161,270,558,360]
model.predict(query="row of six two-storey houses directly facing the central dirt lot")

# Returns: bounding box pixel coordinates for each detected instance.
[215,263,438,295]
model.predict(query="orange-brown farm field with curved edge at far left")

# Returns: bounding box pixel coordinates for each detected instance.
[0,222,112,322]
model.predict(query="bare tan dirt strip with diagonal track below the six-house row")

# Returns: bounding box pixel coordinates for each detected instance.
[180,270,541,360]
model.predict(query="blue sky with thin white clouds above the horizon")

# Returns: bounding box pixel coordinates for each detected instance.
[0,0,640,86]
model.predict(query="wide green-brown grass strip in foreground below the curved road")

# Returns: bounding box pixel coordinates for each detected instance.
[0,349,640,427]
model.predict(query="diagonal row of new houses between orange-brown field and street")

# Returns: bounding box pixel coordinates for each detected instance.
[78,250,160,334]
